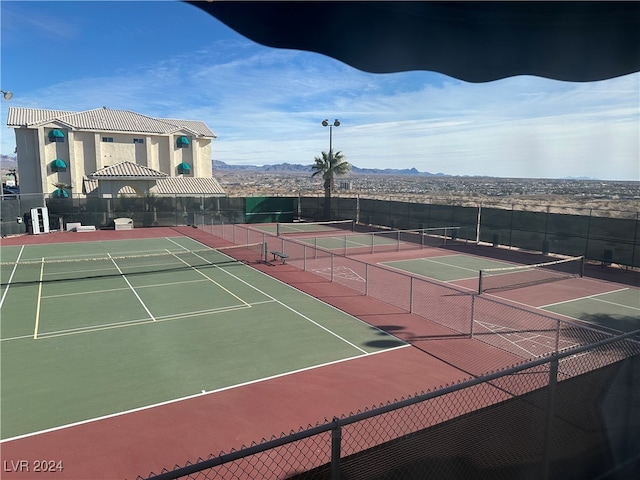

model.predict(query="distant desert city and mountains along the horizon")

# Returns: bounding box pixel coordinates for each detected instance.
[1,155,640,202]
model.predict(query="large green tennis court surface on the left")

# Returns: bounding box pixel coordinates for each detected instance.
[0,237,405,439]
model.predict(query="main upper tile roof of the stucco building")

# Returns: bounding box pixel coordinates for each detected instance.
[7,107,216,138]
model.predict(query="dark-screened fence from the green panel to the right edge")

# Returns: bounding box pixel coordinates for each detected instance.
[300,197,640,267]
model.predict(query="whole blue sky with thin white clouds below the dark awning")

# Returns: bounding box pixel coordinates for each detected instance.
[0,0,640,181]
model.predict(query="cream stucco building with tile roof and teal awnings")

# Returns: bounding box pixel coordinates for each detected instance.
[7,107,224,198]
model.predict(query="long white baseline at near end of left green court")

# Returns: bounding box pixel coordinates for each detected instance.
[0,344,411,444]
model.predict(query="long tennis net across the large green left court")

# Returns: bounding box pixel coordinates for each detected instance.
[0,242,266,287]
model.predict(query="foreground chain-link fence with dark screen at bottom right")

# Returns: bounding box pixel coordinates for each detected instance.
[138,331,640,480]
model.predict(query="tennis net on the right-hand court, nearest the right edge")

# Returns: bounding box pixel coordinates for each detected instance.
[478,257,584,294]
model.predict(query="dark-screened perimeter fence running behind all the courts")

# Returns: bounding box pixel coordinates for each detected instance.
[0,195,640,268]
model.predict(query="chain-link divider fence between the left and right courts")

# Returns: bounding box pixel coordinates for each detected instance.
[198,222,624,359]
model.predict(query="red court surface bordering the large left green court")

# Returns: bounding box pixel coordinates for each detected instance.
[1,227,624,480]
